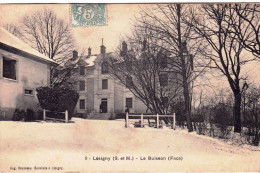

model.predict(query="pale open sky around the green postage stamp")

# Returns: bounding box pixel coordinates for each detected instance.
[0,4,142,54]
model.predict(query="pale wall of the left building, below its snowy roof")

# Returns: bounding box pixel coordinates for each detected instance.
[0,49,50,119]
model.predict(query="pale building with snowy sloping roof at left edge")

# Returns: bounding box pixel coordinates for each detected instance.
[0,27,55,120]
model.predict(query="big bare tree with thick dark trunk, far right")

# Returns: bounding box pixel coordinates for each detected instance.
[190,4,254,132]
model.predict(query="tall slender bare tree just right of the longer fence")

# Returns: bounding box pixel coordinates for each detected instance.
[129,4,207,132]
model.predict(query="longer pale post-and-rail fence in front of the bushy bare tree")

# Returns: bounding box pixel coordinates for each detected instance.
[125,113,176,130]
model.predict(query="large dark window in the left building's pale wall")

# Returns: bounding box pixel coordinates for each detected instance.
[3,57,16,80]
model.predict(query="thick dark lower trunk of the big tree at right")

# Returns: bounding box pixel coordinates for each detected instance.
[233,93,241,133]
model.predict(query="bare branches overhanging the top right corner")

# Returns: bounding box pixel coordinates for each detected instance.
[232,4,260,58]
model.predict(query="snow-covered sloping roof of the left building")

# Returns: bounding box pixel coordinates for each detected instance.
[0,27,56,63]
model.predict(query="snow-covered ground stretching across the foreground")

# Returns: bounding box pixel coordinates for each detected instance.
[0,118,260,172]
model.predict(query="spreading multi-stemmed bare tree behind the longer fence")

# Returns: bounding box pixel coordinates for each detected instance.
[109,28,181,119]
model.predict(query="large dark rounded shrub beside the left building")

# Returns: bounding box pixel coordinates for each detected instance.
[36,86,79,119]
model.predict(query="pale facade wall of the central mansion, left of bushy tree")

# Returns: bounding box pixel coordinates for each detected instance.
[73,54,146,119]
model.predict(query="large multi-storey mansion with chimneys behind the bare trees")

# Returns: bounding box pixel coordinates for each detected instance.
[72,39,187,119]
